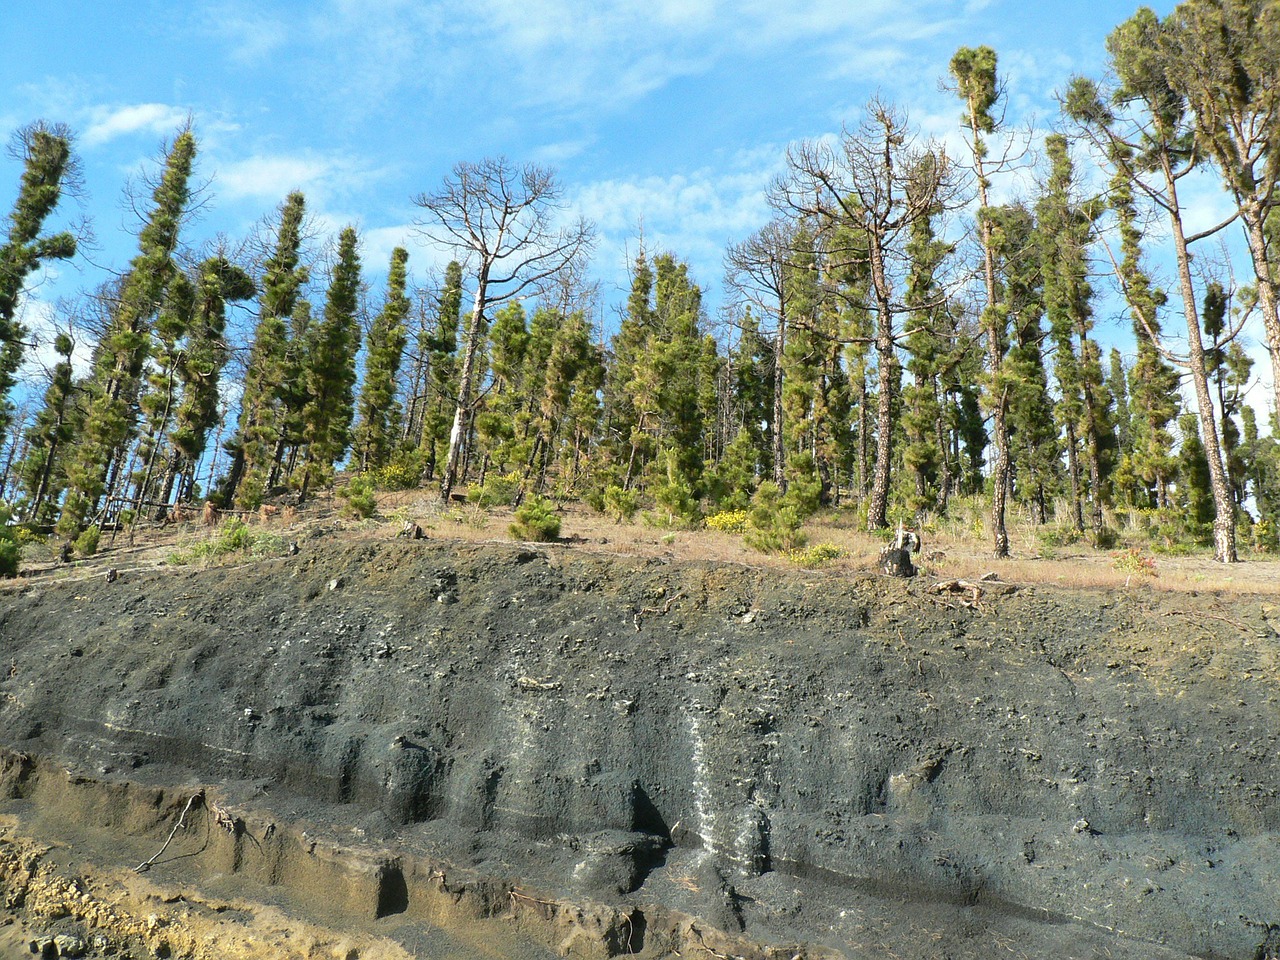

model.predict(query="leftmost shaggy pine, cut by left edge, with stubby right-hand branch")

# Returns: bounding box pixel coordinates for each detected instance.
[0,123,76,434]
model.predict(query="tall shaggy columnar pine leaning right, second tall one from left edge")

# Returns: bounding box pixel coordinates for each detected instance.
[59,128,196,535]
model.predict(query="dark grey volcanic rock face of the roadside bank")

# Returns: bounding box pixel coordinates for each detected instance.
[0,539,1280,957]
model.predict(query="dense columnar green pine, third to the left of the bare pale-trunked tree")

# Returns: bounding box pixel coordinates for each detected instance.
[298,227,360,502]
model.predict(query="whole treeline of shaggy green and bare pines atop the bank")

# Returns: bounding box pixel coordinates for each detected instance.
[0,0,1280,561]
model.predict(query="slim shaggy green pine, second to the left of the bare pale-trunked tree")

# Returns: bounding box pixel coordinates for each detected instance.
[356,247,410,470]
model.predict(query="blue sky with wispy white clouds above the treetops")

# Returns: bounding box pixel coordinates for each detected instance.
[22,0,1262,407]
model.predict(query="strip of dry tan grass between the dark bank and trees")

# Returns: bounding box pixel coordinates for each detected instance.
[15,489,1280,595]
